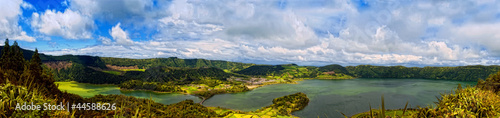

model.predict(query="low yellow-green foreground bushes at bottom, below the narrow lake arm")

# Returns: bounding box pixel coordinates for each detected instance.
[81,95,220,118]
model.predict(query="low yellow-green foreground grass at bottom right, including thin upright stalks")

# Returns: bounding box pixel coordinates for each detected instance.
[352,85,500,118]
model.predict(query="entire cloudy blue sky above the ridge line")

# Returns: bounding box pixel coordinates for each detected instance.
[0,0,500,67]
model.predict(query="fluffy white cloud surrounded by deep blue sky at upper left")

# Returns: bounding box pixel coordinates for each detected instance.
[31,9,96,39]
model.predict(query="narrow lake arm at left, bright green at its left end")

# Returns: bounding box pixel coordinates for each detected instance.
[55,82,201,104]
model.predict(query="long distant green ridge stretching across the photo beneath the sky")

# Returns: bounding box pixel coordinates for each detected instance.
[0,46,500,84]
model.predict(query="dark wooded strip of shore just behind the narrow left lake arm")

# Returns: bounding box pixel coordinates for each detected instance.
[52,63,236,85]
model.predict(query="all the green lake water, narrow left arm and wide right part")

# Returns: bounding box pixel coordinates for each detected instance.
[56,78,476,118]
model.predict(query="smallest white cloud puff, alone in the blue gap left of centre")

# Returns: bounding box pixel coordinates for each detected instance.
[109,23,134,45]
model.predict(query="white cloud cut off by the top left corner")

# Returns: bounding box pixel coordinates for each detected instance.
[0,0,36,42]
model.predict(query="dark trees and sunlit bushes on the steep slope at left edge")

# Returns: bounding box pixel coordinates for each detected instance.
[0,39,83,117]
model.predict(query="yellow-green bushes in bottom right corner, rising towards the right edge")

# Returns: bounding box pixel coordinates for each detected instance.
[416,71,500,117]
